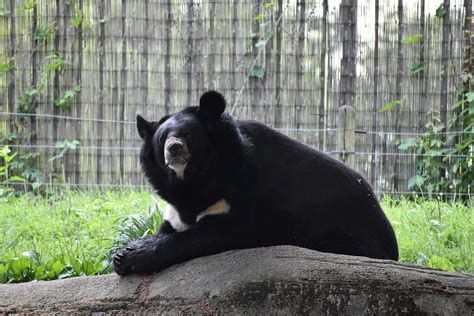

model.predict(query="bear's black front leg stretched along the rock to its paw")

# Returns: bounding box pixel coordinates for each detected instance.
[113,215,256,275]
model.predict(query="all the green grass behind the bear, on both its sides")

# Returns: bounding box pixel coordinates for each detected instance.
[0,188,474,283]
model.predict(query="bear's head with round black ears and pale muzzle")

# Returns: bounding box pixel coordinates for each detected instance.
[137,91,226,186]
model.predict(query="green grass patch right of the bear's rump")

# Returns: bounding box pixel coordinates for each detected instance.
[382,196,474,273]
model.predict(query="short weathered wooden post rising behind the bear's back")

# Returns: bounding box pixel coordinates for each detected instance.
[337,105,357,168]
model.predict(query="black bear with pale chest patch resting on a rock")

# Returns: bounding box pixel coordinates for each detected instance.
[113,91,398,275]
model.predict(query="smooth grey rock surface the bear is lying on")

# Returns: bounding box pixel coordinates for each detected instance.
[0,246,474,315]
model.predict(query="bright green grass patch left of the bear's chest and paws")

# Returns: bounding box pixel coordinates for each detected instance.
[0,190,160,283]
